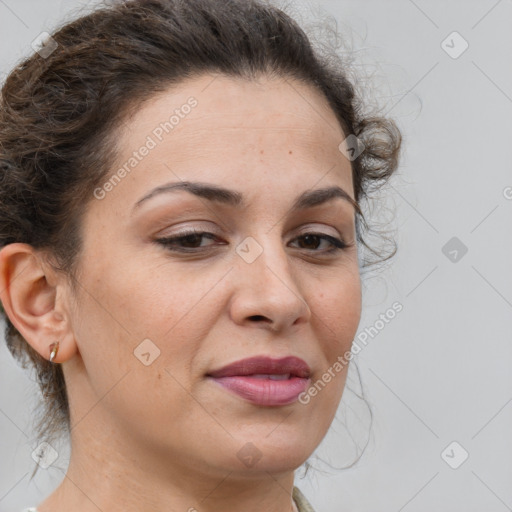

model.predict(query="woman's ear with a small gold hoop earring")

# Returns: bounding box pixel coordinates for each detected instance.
[0,243,78,363]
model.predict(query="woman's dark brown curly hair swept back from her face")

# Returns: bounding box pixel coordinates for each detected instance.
[0,0,401,474]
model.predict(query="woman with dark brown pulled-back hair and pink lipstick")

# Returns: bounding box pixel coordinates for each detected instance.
[0,0,400,512]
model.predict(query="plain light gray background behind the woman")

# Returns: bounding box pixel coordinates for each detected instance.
[0,0,512,512]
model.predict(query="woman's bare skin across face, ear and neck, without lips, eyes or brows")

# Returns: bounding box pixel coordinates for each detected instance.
[0,75,361,512]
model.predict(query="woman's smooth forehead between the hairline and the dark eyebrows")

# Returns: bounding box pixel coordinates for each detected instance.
[94,71,353,214]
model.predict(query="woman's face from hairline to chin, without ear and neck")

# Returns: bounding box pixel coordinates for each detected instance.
[63,76,361,476]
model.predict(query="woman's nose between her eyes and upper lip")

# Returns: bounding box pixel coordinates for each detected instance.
[230,237,311,331]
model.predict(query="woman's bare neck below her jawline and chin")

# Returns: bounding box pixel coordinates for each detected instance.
[38,414,297,512]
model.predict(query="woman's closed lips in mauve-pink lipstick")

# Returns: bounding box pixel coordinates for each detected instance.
[207,356,311,406]
